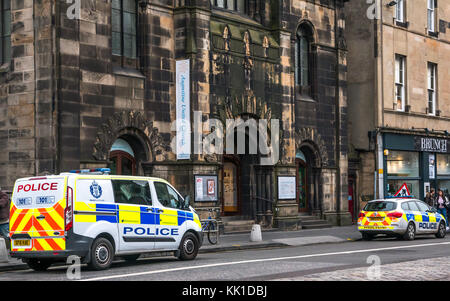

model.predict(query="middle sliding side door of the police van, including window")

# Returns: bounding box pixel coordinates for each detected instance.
[111,179,158,252]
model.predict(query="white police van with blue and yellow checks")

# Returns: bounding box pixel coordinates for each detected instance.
[10,168,203,270]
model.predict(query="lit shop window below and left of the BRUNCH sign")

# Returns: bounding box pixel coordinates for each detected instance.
[387,150,419,178]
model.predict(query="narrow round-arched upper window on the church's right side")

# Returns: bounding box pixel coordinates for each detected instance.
[295,24,313,96]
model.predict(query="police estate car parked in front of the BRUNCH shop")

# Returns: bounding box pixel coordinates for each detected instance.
[358,198,446,240]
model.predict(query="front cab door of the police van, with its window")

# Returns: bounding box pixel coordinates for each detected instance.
[153,181,187,250]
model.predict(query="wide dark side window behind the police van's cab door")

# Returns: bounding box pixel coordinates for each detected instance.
[111,180,152,206]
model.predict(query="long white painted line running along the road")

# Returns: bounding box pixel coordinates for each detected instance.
[81,242,450,281]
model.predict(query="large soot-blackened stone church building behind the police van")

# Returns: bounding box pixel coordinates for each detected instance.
[0,0,351,229]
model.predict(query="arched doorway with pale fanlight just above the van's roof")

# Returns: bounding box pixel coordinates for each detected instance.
[109,138,136,175]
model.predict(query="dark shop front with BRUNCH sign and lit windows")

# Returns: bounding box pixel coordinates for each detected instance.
[383,133,450,200]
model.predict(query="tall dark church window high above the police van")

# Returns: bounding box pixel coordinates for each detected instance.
[111,0,137,68]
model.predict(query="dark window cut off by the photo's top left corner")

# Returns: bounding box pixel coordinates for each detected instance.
[0,0,11,65]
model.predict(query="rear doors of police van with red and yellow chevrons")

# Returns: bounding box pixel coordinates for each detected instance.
[10,176,67,251]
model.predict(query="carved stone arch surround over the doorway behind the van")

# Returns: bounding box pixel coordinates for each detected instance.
[93,111,170,162]
